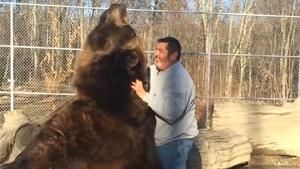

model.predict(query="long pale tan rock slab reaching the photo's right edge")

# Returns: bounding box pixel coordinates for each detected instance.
[214,100,300,157]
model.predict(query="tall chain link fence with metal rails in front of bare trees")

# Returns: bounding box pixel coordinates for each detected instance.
[0,2,300,124]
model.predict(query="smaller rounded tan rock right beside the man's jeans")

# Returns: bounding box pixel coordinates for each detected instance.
[187,129,252,169]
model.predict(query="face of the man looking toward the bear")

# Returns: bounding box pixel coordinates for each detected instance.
[154,42,177,71]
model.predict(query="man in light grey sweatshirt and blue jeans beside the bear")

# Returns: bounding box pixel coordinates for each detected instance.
[132,37,198,169]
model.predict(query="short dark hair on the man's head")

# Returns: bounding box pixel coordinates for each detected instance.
[156,36,181,60]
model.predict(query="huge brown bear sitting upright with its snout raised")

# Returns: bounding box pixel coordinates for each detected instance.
[0,4,162,169]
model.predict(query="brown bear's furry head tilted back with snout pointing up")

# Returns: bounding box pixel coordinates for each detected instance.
[74,4,146,111]
